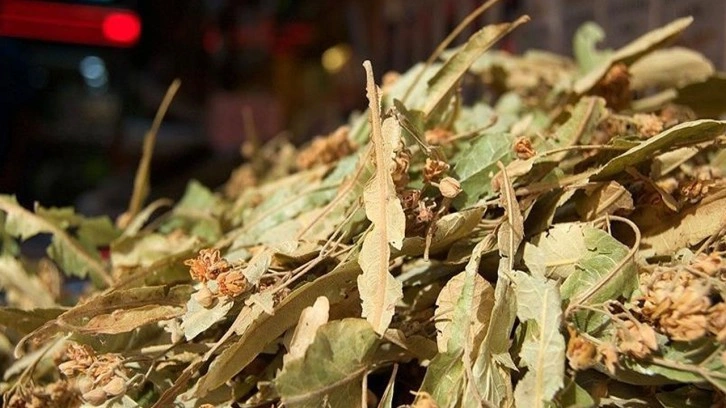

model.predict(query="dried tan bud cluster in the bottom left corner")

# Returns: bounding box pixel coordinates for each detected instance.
[58,343,129,406]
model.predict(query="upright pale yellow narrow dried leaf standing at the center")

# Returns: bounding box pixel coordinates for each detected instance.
[358,61,406,334]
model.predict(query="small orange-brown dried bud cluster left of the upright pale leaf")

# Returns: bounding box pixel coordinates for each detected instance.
[184,248,250,307]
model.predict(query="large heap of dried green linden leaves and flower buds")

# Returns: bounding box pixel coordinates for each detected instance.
[0,9,726,408]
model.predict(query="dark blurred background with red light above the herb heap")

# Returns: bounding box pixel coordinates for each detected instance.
[0,0,726,216]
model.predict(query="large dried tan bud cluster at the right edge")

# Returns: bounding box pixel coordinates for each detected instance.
[639,254,726,343]
